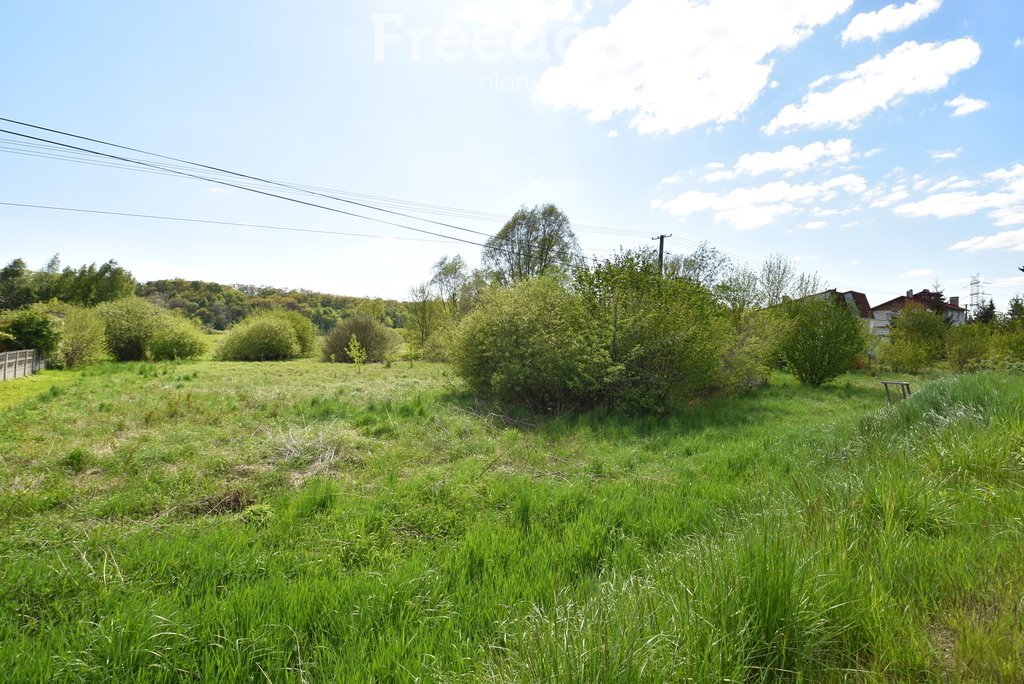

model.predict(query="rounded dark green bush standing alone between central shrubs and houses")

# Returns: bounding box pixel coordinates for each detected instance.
[781,297,868,387]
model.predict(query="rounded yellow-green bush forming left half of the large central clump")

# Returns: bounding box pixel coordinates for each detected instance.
[451,277,610,409]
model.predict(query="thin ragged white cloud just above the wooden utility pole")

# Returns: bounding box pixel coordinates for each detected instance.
[653,174,866,230]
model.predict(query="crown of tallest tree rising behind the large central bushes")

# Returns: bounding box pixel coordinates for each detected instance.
[482,204,581,286]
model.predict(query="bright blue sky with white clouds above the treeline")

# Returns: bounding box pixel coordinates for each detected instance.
[0,0,1024,307]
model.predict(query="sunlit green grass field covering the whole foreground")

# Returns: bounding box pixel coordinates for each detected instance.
[0,360,1024,682]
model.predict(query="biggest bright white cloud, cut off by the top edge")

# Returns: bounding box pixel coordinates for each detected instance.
[537,0,853,134]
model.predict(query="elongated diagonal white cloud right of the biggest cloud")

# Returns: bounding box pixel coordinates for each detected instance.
[763,38,981,134]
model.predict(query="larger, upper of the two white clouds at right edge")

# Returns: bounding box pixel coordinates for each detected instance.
[894,164,1024,228]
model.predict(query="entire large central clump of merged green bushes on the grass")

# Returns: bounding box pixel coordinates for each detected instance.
[449,252,766,413]
